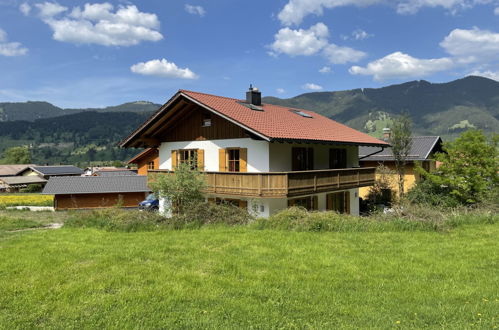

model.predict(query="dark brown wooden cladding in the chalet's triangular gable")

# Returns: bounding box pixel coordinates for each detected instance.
[160,105,248,142]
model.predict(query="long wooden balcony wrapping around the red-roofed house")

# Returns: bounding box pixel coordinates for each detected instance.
[149,167,376,198]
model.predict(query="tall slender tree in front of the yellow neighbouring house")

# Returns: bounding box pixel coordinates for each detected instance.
[390,114,412,199]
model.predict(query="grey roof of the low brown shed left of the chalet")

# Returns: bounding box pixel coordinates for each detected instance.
[42,175,151,195]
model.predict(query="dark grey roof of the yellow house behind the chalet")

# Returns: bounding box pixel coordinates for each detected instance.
[359,136,442,162]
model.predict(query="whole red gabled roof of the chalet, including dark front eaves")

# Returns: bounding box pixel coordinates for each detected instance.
[120,90,389,147]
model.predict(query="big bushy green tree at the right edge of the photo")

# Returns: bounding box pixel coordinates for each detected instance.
[418,130,499,204]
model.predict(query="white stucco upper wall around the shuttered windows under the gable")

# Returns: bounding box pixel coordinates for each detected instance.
[159,138,269,172]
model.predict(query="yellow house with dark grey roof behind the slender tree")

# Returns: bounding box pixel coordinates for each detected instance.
[359,133,442,199]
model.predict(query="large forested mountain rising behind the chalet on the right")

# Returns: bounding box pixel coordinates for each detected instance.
[263,76,499,138]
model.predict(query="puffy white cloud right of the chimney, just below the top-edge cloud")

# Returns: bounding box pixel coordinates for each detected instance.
[270,23,366,64]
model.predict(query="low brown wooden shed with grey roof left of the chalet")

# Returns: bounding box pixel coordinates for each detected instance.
[42,175,150,210]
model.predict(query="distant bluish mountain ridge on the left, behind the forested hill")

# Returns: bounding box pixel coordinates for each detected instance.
[0,101,160,122]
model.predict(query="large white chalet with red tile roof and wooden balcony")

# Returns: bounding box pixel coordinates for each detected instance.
[120,87,389,216]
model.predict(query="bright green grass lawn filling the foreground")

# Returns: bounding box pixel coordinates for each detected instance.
[0,217,499,329]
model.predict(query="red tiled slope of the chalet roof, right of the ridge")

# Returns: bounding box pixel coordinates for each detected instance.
[179,90,388,146]
